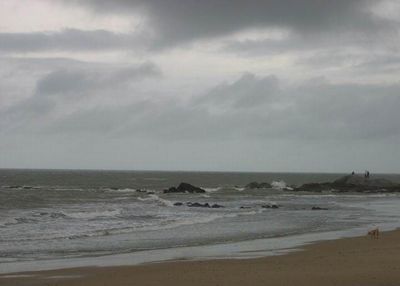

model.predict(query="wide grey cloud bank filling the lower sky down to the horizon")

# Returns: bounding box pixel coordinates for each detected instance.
[0,69,400,171]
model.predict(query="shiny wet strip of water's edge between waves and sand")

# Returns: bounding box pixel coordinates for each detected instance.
[0,223,399,274]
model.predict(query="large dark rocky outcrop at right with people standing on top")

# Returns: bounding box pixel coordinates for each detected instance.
[294,175,400,192]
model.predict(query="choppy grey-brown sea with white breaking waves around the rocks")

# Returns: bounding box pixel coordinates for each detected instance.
[0,170,400,268]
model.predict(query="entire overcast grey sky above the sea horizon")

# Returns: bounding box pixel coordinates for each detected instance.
[0,0,400,173]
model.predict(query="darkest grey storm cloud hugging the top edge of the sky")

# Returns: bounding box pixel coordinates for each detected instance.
[65,0,378,46]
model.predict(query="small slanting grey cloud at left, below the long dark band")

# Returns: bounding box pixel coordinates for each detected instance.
[0,61,161,132]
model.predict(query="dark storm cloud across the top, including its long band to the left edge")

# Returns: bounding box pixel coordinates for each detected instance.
[0,0,399,55]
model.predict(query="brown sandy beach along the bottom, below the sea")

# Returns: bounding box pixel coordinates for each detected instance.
[0,230,400,286]
